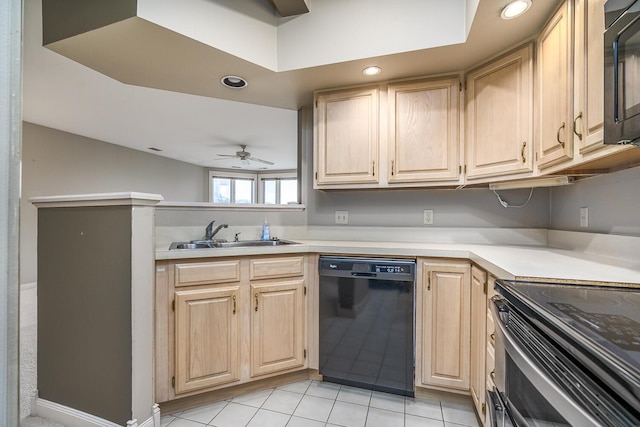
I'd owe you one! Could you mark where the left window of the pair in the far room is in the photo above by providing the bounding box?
[209,171,256,204]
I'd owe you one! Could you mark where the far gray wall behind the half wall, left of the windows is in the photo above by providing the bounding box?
[20,122,209,283]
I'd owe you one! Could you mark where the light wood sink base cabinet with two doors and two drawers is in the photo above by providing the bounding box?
[155,255,307,402]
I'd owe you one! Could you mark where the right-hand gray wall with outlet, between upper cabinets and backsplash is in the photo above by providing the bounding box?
[549,167,640,236]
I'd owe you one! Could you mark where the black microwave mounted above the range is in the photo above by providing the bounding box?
[604,0,640,146]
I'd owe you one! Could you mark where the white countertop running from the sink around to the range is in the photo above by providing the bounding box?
[156,240,640,286]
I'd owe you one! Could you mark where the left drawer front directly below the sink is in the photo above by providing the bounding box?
[175,260,240,287]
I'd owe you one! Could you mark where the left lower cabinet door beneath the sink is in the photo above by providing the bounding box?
[175,286,240,394]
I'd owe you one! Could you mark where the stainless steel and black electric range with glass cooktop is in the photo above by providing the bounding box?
[487,280,640,427]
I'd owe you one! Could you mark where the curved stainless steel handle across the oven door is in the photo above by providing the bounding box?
[492,301,599,426]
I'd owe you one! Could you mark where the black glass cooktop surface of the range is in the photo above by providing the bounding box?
[495,280,640,406]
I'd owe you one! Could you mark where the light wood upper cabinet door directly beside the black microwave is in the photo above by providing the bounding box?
[573,0,604,154]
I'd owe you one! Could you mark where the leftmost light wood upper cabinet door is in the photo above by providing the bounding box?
[315,87,379,186]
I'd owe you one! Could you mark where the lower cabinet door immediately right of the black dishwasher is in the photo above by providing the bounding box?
[421,263,470,390]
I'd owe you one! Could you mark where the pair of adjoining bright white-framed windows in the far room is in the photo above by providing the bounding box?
[209,170,299,205]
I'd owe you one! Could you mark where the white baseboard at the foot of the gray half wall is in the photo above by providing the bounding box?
[34,398,160,427]
